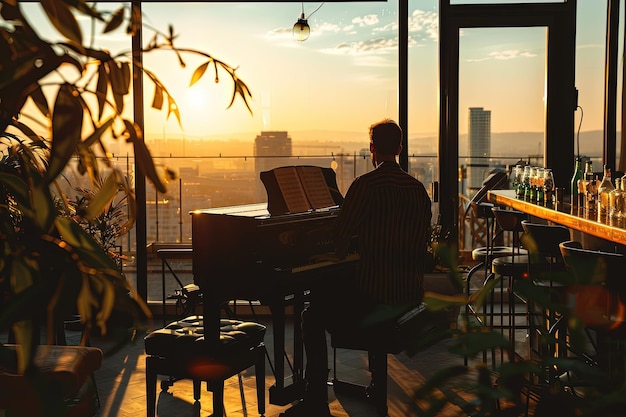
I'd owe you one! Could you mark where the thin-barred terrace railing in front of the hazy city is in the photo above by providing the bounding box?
[59,153,588,302]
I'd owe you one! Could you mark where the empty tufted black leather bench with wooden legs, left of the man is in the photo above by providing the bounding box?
[144,316,266,417]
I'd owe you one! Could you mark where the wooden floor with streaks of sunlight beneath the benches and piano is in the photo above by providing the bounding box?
[89,316,472,417]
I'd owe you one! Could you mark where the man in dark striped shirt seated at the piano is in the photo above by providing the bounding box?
[282,119,431,417]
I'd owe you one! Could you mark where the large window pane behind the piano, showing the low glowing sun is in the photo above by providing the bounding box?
[137,2,404,299]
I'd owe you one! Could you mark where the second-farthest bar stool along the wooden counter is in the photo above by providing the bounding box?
[489,207,528,368]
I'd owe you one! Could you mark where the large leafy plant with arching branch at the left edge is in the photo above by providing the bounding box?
[0,0,251,372]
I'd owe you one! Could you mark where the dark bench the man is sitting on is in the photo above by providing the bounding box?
[330,303,432,417]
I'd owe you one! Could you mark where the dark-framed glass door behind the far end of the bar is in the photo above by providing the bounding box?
[439,0,576,247]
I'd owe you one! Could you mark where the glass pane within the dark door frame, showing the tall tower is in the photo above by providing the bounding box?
[459,27,546,198]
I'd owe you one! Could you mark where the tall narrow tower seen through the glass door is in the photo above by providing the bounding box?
[465,107,491,193]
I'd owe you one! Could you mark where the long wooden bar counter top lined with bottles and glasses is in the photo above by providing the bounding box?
[487,190,626,245]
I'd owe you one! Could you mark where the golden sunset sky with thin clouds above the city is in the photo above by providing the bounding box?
[13,0,608,144]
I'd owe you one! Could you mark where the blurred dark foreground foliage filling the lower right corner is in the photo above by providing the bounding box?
[410,240,626,417]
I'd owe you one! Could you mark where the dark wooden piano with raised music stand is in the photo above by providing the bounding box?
[191,168,358,405]
